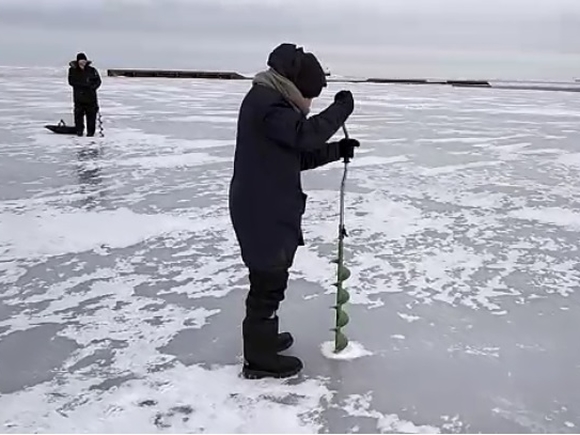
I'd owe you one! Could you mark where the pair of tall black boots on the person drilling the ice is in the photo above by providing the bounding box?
[242,317,303,379]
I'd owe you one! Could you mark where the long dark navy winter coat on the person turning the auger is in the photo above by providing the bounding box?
[229,85,352,270]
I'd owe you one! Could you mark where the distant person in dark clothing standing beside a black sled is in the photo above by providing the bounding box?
[68,53,101,136]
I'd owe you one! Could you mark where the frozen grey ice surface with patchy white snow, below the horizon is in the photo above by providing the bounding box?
[0,66,580,433]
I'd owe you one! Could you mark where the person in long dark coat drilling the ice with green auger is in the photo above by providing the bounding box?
[229,43,359,379]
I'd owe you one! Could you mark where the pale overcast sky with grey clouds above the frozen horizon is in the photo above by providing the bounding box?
[0,0,580,79]
